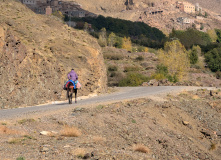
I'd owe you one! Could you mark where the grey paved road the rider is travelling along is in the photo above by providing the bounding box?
[0,86,212,121]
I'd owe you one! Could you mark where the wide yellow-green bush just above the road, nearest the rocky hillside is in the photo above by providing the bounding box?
[119,73,150,86]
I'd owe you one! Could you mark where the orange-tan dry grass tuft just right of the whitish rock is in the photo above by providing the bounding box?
[61,126,81,137]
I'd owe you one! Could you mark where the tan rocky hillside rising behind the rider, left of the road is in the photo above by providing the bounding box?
[0,0,106,108]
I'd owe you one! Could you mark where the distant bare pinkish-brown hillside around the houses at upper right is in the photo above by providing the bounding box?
[74,0,221,34]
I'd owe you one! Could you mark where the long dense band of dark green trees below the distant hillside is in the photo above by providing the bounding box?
[72,15,166,48]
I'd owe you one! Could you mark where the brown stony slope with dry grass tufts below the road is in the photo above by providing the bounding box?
[0,89,221,160]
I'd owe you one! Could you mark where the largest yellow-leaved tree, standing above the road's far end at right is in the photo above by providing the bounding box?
[159,40,190,80]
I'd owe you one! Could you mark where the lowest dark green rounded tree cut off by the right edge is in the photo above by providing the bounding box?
[205,47,221,72]
